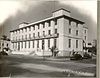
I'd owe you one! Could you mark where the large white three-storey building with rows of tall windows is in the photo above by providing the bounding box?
[10,9,88,56]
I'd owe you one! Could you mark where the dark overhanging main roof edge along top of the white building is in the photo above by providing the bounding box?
[10,15,85,32]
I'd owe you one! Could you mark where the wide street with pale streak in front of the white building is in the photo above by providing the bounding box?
[0,55,96,77]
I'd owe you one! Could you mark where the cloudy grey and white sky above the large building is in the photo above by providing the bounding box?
[0,0,97,41]
